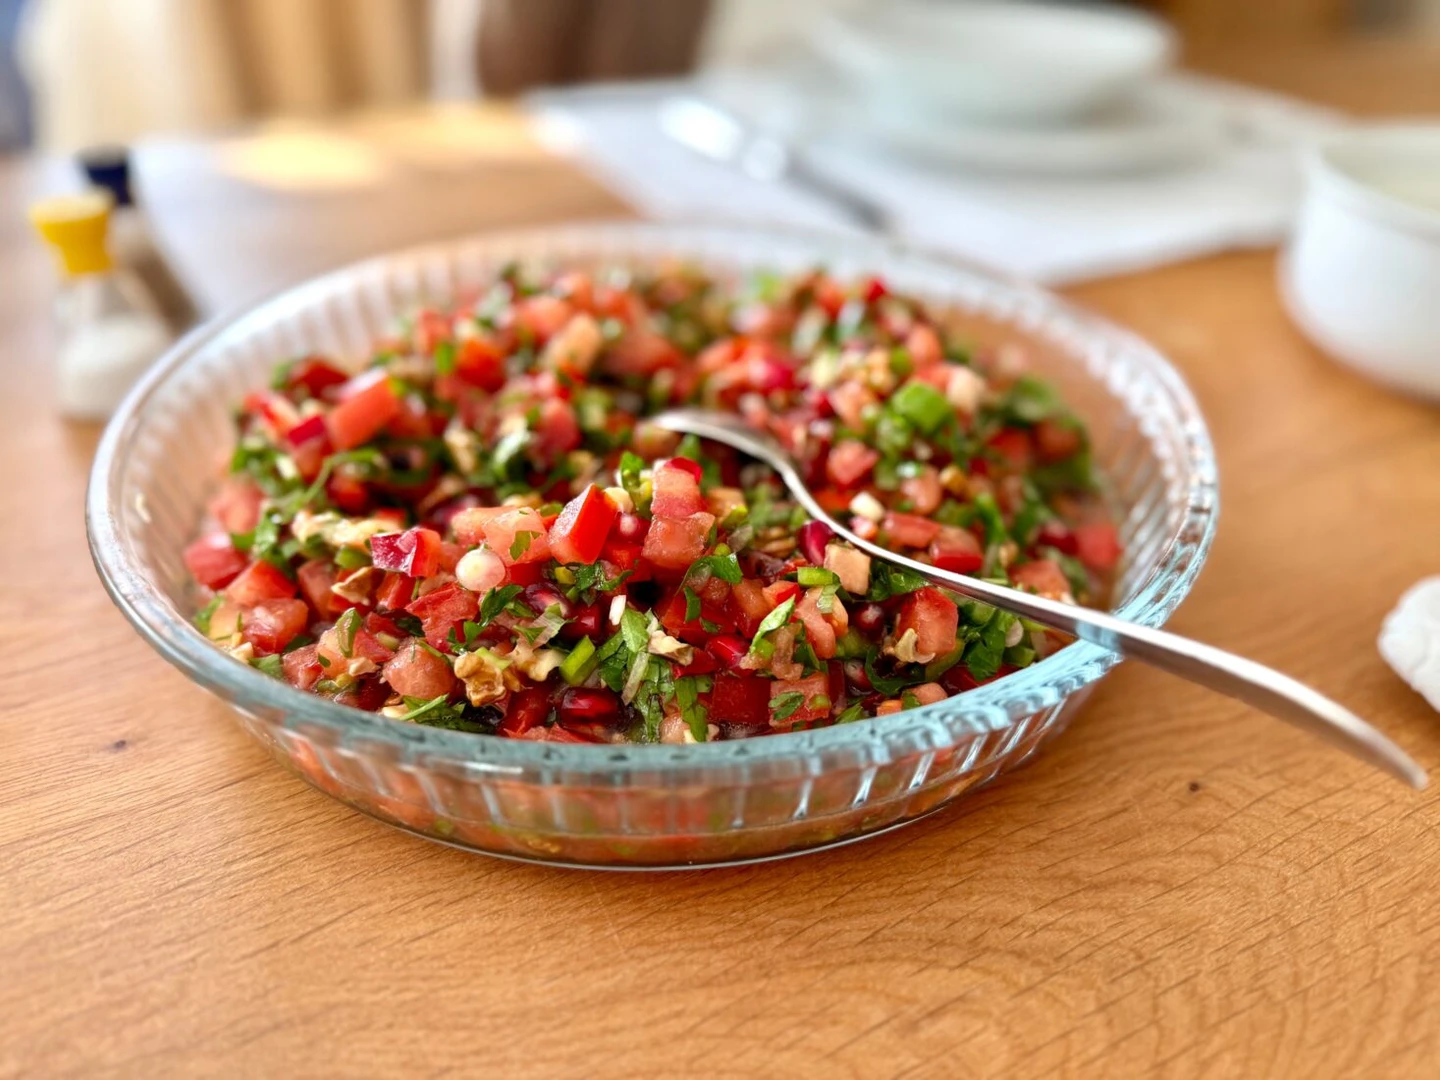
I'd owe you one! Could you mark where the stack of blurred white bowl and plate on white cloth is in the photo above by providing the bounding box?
[811,0,1228,174]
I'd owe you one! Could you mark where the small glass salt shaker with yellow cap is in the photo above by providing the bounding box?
[30,190,174,420]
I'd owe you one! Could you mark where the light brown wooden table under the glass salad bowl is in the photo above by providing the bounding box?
[8,38,1440,1077]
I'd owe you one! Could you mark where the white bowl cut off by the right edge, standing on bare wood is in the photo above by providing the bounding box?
[1280,124,1440,399]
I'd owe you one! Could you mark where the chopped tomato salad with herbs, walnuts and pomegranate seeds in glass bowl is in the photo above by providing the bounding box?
[184,266,1120,743]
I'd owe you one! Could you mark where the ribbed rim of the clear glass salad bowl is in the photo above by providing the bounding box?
[85,220,1218,782]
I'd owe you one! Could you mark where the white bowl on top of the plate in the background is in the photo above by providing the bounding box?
[814,0,1175,124]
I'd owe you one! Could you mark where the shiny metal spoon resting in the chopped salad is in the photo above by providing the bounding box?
[649,409,1427,789]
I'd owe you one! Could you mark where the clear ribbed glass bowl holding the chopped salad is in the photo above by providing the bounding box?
[86,222,1217,867]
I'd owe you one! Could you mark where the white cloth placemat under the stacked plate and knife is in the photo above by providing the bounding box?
[528,75,1339,284]
